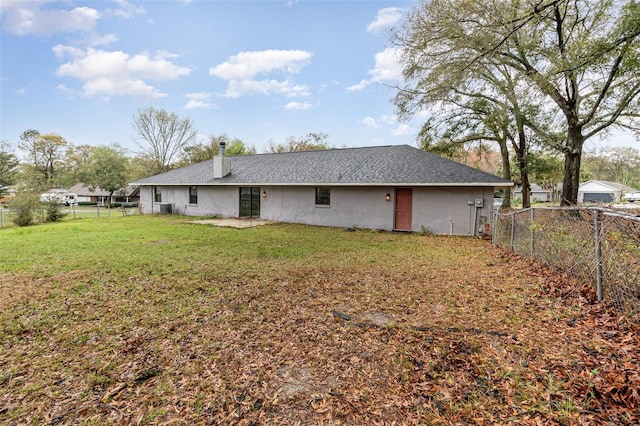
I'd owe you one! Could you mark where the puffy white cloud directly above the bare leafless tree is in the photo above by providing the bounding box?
[53,45,191,100]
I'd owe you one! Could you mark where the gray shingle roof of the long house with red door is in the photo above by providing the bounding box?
[132,145,511,186]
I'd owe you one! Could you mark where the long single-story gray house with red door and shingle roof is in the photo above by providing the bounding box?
[131,144,512,235]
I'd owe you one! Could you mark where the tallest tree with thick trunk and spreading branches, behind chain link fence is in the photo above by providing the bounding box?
[396,0,640,205]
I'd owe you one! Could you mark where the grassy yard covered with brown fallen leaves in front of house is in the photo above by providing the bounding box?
[0,216,640,425]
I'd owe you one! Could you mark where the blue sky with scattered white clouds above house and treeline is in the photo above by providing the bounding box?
[0,0,420,153]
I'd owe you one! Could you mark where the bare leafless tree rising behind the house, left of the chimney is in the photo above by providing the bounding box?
[133,107,197,173]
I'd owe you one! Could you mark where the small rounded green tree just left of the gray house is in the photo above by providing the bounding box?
[85,144,129,199]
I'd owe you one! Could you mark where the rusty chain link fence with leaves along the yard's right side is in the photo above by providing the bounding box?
[493,206,640,317]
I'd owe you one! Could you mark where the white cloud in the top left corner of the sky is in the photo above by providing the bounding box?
[1,0,100,36]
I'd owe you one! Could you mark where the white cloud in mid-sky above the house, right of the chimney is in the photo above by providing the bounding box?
[209,50,313,98]
